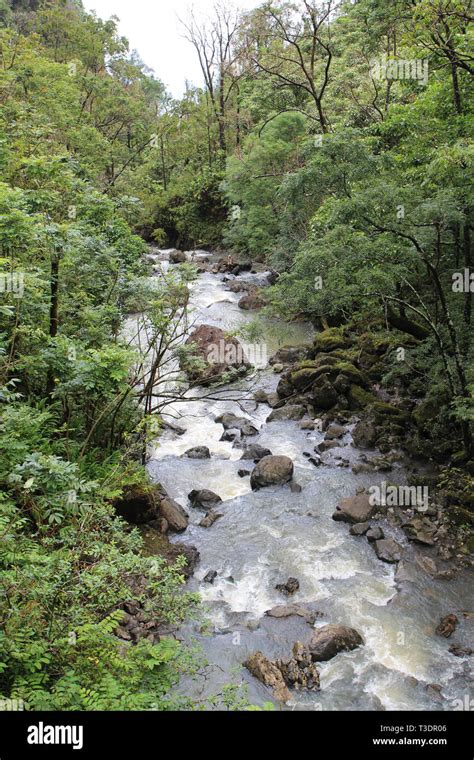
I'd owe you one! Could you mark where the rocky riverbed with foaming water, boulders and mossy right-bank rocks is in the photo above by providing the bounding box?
[131,246,474,710]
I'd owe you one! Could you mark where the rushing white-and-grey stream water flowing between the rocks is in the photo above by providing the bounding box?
[145,249,474,710]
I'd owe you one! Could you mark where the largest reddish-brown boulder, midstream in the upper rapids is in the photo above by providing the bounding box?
[180,325,250,385]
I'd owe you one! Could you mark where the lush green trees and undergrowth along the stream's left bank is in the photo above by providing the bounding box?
[0,2,202,710]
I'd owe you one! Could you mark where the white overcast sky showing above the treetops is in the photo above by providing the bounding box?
[83,0,262,97]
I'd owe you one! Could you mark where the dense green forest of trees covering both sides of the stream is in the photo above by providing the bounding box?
[0,0,474,709]
